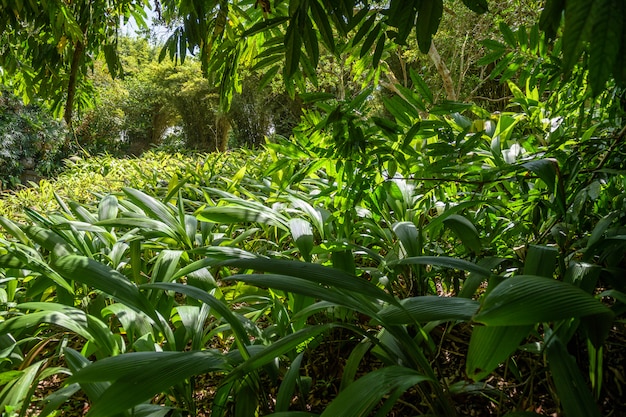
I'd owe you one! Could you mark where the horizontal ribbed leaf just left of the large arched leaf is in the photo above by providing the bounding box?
[379,296,480,324]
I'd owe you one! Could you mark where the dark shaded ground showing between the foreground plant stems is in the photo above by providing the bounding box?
[28,322,626,417]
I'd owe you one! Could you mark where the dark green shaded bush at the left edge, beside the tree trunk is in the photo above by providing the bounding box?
[0,88,67,187]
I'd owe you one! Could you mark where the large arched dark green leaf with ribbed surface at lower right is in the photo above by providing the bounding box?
[474,275,612,326]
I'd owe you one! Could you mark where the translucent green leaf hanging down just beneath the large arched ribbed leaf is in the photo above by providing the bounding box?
[465,326,533,381]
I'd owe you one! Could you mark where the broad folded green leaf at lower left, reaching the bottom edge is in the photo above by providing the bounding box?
[68,350,228,417]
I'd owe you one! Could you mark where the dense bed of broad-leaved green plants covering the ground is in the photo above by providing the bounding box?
[0,64,626,416]
